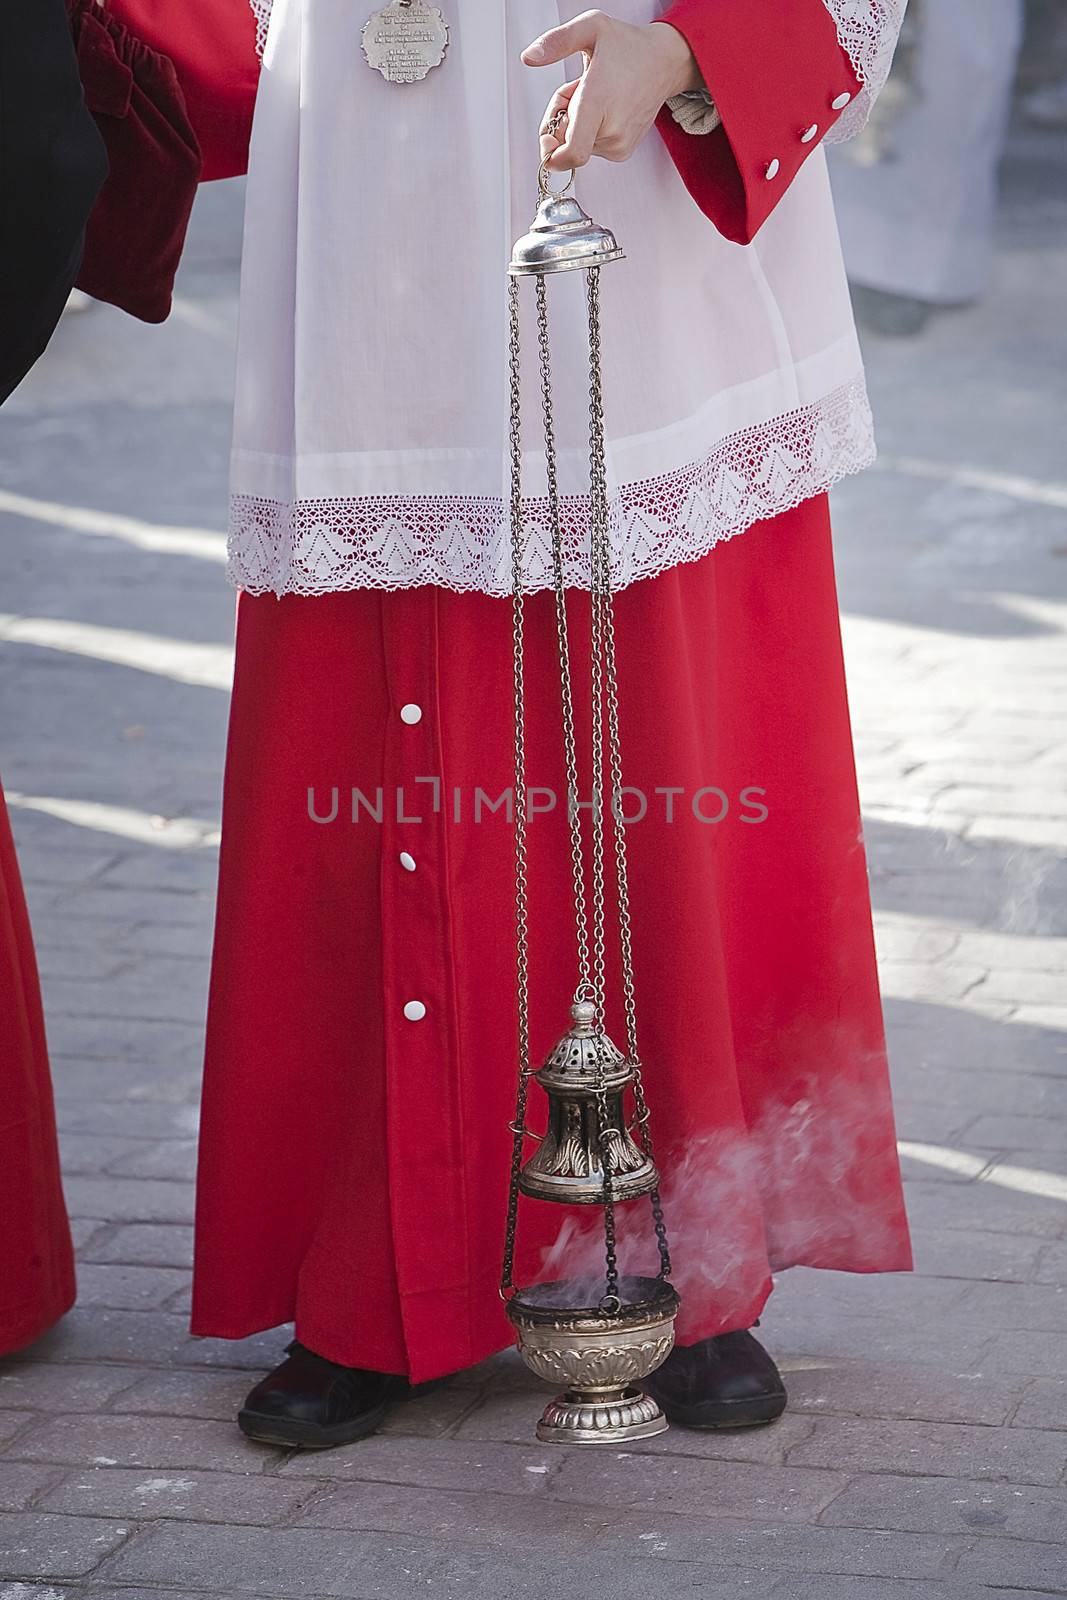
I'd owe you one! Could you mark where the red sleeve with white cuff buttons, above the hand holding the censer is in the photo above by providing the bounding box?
[657,0,861,245]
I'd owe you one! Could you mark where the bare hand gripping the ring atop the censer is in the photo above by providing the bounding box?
[523,11,702,171]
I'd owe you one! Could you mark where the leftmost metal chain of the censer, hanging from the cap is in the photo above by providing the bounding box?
[501,278,530,1299]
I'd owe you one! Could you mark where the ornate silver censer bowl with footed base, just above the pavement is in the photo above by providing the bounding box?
[507,1277,678,1445]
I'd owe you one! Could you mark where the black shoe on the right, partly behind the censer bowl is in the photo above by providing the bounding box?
[645,1328,785,1429]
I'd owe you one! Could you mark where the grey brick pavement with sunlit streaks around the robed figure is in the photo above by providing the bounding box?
[0,124,1067,1600]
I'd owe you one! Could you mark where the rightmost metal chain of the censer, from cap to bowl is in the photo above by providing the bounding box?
[587,267,670,1278]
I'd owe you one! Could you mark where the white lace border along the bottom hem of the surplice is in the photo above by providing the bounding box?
[229,379,875,595]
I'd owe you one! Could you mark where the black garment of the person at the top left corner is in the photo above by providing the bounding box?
[0,0,107,402]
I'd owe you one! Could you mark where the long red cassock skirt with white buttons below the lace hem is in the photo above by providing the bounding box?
[192,498,910,1381]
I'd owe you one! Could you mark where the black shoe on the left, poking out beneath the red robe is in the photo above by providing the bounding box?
[237,1341,430,1450]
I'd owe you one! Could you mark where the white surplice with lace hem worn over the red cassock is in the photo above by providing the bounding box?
[230,0,902,594]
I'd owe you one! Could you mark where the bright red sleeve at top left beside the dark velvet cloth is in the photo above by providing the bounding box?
[107,0,259,179]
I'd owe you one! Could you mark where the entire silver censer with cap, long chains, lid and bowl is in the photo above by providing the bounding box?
[501,163,678,1443]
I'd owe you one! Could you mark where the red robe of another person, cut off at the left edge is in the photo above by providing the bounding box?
[0,789,74,1355]
